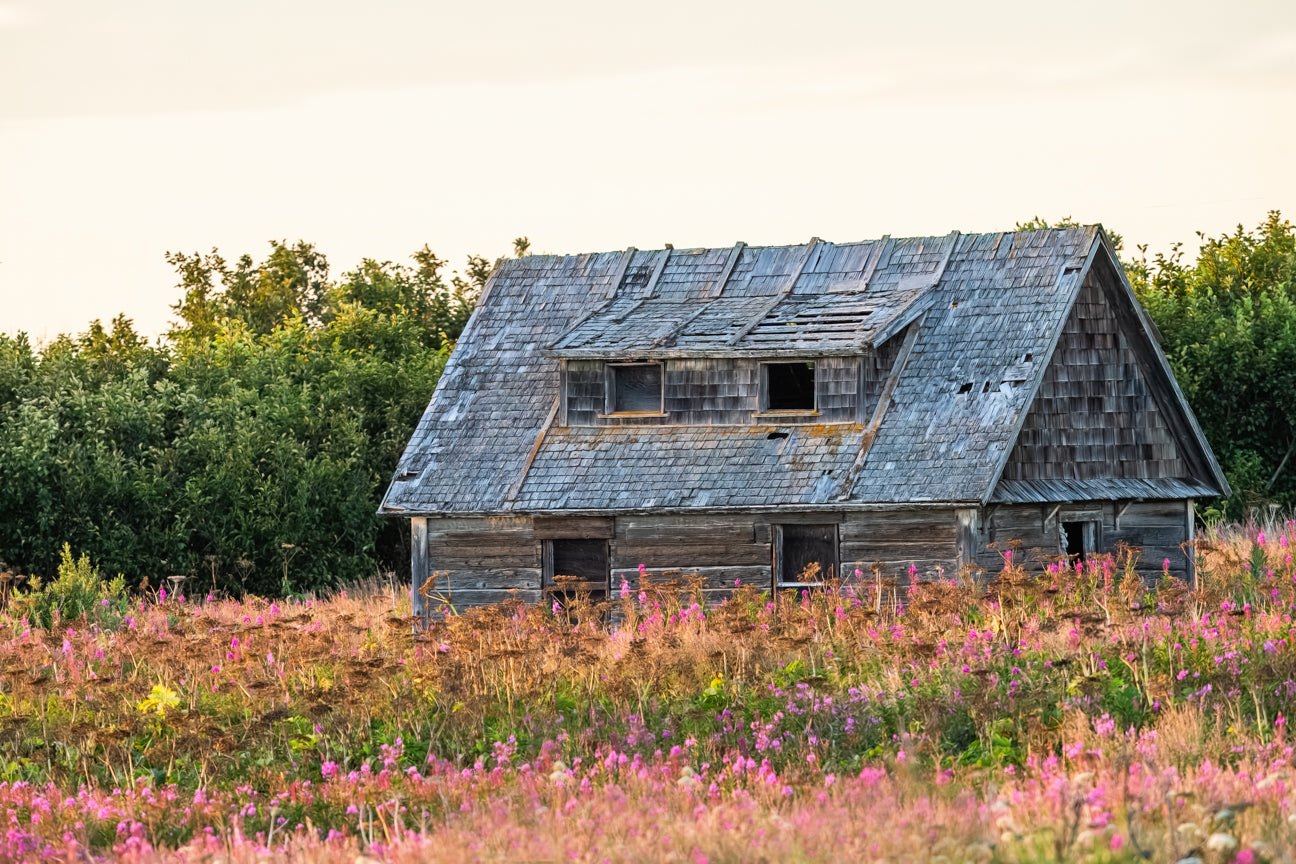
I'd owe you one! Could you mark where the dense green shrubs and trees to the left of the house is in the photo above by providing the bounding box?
[0,244,486,593]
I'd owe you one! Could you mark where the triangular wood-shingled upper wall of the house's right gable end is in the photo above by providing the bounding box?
[994,273,1186,481]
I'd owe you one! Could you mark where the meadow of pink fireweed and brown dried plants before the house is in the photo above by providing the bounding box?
[0,522,1296,864]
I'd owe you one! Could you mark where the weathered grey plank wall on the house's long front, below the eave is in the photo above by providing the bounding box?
[425,508,959,608]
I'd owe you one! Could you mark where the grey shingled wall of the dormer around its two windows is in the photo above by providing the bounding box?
[565,357,865,426]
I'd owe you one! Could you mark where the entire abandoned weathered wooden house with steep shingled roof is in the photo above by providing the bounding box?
[381,225,1227,610]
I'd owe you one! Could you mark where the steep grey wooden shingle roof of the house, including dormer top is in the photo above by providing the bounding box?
[381,227,1227,514]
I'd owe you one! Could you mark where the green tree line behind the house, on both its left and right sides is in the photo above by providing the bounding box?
[0,220,1296,595]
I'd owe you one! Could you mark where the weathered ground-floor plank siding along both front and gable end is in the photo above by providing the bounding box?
[411,500,1192,609]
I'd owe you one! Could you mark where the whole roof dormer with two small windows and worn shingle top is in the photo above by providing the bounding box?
[544,234,956,426]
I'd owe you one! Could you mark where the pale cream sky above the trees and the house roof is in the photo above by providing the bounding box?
[0,0,1296,338]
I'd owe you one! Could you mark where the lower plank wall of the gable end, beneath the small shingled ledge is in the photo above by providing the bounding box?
[976,500,1192,579]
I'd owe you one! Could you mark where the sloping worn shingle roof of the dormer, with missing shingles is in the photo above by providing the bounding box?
[546,233,959,359]
